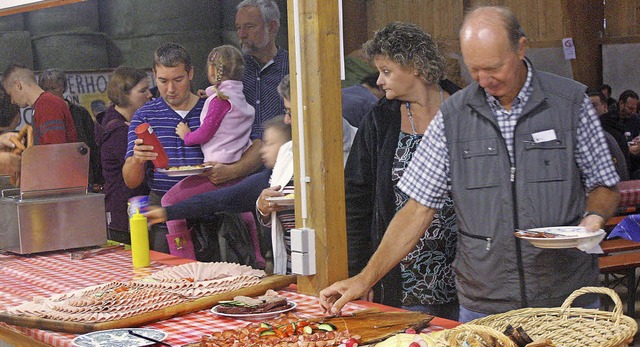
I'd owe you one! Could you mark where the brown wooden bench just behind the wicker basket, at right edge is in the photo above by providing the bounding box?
[598,251,640,318]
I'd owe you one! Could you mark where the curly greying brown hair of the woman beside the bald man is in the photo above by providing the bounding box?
[362,22,445,84]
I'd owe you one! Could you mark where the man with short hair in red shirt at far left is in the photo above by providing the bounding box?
[2,64,78,145]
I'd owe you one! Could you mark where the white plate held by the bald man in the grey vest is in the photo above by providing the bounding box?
[515,226,604,248]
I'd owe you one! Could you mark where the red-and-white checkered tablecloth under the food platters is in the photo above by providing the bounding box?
[0,250,366,347]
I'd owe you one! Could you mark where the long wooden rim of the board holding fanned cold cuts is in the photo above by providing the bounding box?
[0,275,296,334]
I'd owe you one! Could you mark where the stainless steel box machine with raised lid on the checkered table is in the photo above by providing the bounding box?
[0,143,107,254]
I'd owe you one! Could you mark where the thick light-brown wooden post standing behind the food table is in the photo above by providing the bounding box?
[287,0,348,295]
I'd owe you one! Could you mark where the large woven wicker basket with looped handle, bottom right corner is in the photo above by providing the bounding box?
[458,287,638,347]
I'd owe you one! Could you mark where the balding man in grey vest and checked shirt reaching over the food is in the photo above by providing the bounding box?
[320,7,619,322]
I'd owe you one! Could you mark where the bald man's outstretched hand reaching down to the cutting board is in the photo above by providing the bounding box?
[319,275,370,315]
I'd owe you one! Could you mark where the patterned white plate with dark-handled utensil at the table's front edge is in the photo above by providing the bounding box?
[72,328,168,347]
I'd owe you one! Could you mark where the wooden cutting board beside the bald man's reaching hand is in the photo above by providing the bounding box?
[182,309,433,347]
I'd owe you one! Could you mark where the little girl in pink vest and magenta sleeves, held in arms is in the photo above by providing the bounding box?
[162,45,264,266]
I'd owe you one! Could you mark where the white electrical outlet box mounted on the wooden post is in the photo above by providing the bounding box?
[291,228,316,276]
